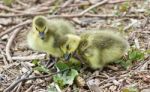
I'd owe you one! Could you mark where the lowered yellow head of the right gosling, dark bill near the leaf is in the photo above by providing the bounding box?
[60,34,80,61]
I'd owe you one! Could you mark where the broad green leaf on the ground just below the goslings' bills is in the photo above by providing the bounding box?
[53,59,78,88]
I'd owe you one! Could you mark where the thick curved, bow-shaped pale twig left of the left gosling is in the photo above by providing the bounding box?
[6,28,21,62]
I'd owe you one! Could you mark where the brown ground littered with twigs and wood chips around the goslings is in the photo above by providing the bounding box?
[0,0,150,92]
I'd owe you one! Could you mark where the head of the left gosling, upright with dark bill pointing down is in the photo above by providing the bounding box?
[32,16,48,40]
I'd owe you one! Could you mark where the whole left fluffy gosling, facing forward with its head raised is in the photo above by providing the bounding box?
[27,16,75,57]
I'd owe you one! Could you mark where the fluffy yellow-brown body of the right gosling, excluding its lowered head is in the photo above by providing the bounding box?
[77,30,129,69]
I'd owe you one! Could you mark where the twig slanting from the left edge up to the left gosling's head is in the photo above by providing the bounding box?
[0,20,31,38]
